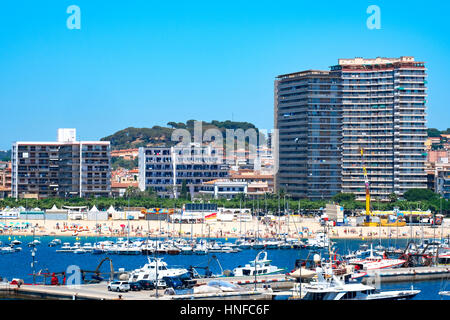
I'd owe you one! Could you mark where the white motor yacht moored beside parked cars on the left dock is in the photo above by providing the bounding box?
[129,257,189,282]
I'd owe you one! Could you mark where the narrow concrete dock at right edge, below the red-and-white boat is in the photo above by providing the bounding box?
[362,266,450,283]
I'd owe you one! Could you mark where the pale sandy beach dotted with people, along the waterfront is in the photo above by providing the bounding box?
[0,217,450,240]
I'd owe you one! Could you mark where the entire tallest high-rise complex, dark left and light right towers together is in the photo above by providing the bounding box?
[275,57,427,200]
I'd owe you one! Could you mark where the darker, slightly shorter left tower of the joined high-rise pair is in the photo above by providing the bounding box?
[273,70,341,199]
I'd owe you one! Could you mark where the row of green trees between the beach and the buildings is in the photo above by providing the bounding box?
[0,187,450,215]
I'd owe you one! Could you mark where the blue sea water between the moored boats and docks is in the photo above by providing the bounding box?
[0,235,450,300]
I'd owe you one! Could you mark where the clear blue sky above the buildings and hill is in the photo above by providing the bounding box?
[0,0,450,149]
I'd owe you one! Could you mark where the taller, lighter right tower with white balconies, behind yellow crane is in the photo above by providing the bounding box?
[331,57,427,199]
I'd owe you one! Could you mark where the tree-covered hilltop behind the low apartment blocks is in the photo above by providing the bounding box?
[100,120,258,149]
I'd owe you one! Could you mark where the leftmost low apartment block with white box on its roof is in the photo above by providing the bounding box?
[12,129,111,198]
